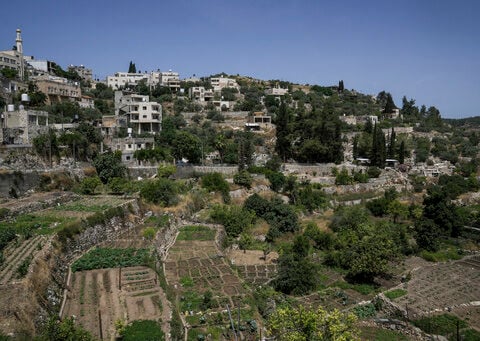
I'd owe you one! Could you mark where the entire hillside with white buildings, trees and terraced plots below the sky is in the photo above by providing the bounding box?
[0,30,480,340]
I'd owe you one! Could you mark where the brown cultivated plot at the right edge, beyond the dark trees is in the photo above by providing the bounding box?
[394,255,480,329]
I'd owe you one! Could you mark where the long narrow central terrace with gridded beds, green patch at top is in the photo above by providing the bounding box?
[165,226,258,340]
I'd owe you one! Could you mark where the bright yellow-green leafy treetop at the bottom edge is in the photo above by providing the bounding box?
[267,306,358,341]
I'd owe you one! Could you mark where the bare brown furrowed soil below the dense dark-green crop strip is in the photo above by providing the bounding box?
[63,266,163,339]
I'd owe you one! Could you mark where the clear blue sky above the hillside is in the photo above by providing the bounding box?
[0,0,480,117]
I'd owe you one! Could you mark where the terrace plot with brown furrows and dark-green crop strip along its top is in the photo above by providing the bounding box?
[62,248,168,339]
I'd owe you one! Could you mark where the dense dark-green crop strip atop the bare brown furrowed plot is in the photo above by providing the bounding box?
[72,248,149,272]
